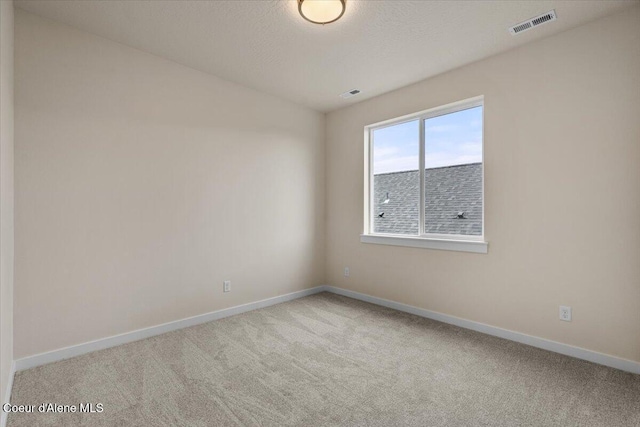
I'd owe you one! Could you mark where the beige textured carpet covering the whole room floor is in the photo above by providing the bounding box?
[8,293,640,427]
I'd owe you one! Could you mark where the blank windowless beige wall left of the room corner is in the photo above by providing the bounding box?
[15,10,325,358]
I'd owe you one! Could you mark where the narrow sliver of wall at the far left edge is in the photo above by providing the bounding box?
[0,1,13,403]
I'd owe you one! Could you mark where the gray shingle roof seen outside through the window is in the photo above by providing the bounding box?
[373,163,482,236]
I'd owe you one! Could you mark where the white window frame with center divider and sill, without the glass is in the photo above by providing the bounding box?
[360,96,489,253]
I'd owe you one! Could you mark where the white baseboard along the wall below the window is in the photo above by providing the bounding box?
[324,286,640,374]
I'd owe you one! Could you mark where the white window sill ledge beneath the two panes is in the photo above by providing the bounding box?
[360,234,489,254]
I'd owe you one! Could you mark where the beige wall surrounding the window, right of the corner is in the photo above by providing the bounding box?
[326,6,640,361]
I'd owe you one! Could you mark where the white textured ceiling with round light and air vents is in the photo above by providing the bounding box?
[16,0,638,111]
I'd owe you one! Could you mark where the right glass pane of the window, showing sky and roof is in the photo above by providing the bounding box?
[424,106,482,236]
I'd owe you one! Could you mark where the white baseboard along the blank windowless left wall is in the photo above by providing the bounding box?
[15,286,326,371]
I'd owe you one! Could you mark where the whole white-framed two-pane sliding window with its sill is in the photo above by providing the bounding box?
[361,97,487,253]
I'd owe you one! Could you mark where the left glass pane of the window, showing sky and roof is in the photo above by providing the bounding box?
[372,120,420,235]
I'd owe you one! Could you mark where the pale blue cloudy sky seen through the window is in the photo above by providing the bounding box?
[373,107,482,174]
